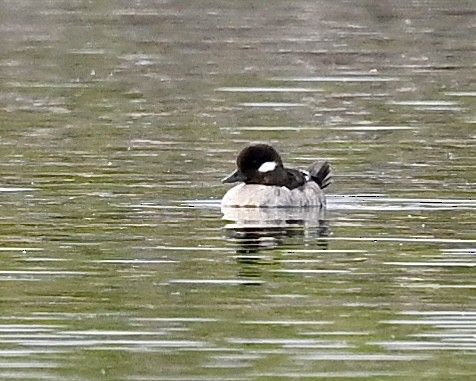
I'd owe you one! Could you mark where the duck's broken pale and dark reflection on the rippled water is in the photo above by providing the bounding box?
[222,207,329,254]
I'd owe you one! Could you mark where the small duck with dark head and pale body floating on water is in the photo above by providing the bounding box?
[221,144,331,207]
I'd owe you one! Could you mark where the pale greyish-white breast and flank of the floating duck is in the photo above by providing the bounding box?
[221,182,325,207]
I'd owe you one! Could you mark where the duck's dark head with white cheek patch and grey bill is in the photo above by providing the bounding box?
[222,144,283,184]
